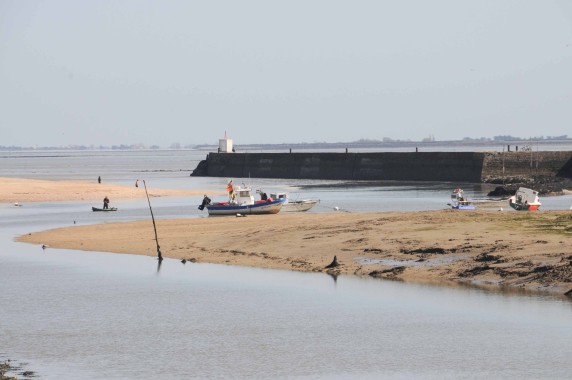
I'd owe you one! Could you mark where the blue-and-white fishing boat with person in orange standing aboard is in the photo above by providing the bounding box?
[204,181,286,216]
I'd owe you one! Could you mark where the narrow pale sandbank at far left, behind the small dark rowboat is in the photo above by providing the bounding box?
[0,177,212,204]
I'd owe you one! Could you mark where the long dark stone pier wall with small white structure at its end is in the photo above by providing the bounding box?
[192,152,572,182]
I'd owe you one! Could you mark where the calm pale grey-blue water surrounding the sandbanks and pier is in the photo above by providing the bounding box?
[0,151,572,379]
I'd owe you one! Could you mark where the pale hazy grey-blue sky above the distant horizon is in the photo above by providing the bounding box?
[0,0,572,147]
